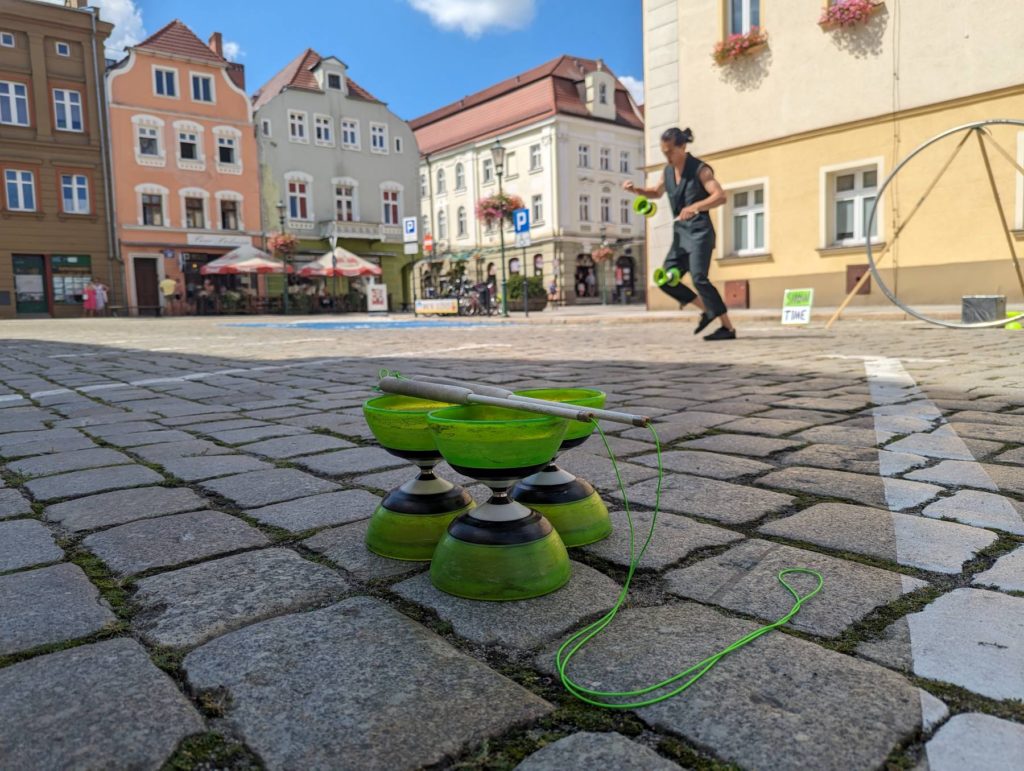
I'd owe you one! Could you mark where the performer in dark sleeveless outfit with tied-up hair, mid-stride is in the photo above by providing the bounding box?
[623,128,736,340]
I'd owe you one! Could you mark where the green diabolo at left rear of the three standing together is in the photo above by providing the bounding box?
[362,394,474,561]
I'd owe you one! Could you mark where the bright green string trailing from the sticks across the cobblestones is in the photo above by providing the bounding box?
[555,420,824,710]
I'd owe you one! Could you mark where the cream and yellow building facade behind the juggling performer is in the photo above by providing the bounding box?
[644,0,1024,309]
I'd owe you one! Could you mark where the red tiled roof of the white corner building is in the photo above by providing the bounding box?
[410,56,643,155]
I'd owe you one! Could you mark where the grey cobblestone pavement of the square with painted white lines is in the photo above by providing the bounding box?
[0,319,1024,771]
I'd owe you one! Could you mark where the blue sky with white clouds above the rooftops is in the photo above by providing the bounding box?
[77,0,643,120]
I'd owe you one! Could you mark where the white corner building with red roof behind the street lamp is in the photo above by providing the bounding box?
[412,56,645,304]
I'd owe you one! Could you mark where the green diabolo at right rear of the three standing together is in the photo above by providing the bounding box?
[510,388,611,547]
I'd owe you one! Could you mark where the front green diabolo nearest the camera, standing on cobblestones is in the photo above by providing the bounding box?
[427,404,571,600]
